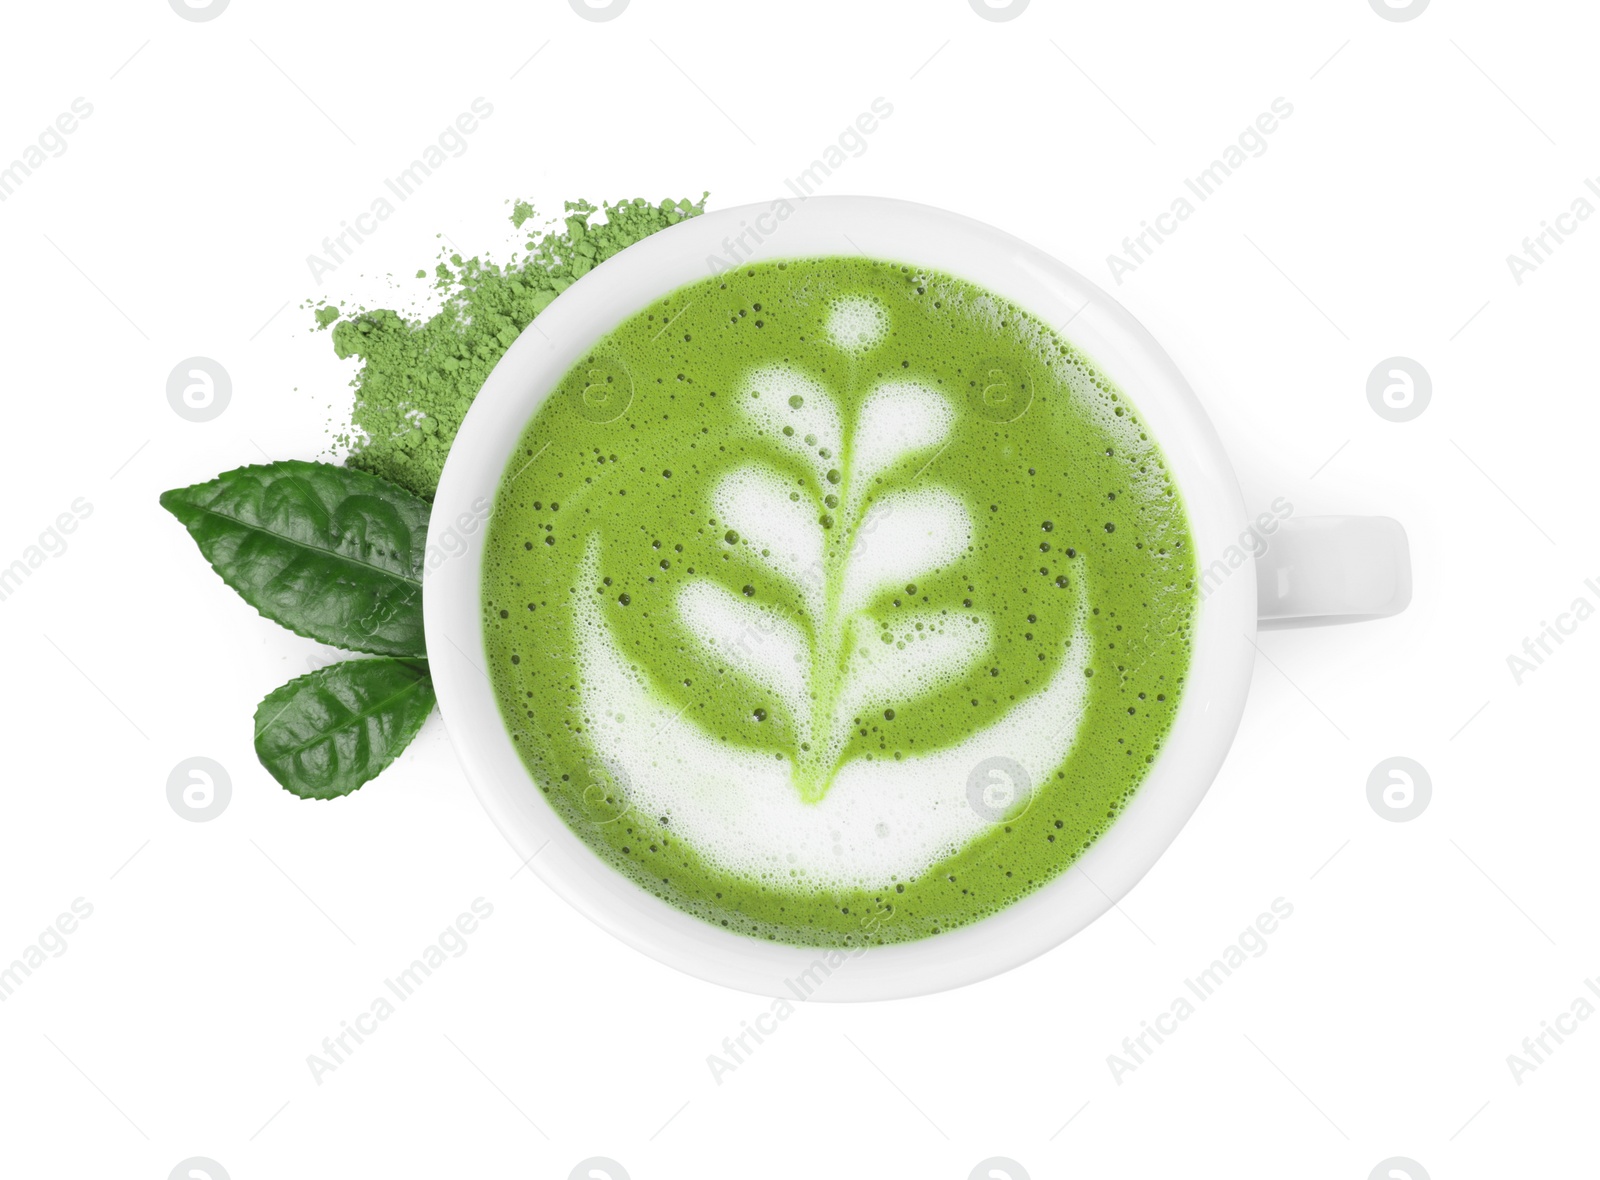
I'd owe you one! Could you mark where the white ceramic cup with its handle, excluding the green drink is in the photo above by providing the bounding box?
[422,197,1411,999]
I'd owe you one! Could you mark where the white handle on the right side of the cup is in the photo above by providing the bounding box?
[1256,516,1411,630]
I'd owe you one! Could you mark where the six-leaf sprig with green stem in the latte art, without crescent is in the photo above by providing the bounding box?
[678,358,989,803]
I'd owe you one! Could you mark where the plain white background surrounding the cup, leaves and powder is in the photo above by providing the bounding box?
[0,0,1600,1180]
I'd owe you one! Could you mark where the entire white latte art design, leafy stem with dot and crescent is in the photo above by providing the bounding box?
[579,308,1088,887]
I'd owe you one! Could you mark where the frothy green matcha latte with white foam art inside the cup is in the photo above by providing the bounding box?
[483,257,1197,945]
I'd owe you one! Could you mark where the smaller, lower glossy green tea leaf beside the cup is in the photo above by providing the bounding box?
[256,659,434,799]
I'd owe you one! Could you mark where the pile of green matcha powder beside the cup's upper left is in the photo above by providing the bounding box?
[315,197,706,499]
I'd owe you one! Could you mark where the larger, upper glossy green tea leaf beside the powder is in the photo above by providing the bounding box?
[162,459,429,656]
